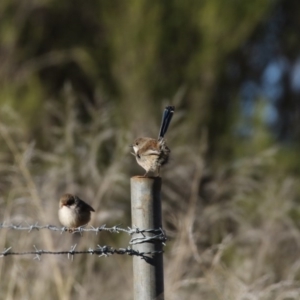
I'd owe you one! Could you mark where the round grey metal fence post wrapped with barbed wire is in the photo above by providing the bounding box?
[130,176,164,300]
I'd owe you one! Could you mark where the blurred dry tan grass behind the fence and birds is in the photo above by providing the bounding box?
[0,97,300,300]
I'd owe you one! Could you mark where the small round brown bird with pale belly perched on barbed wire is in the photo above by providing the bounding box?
[58,194,95,229]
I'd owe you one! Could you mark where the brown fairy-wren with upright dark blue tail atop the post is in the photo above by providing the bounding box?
[132,106,175,177]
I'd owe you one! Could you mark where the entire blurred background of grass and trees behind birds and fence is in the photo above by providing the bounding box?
[0,0,300,300]
